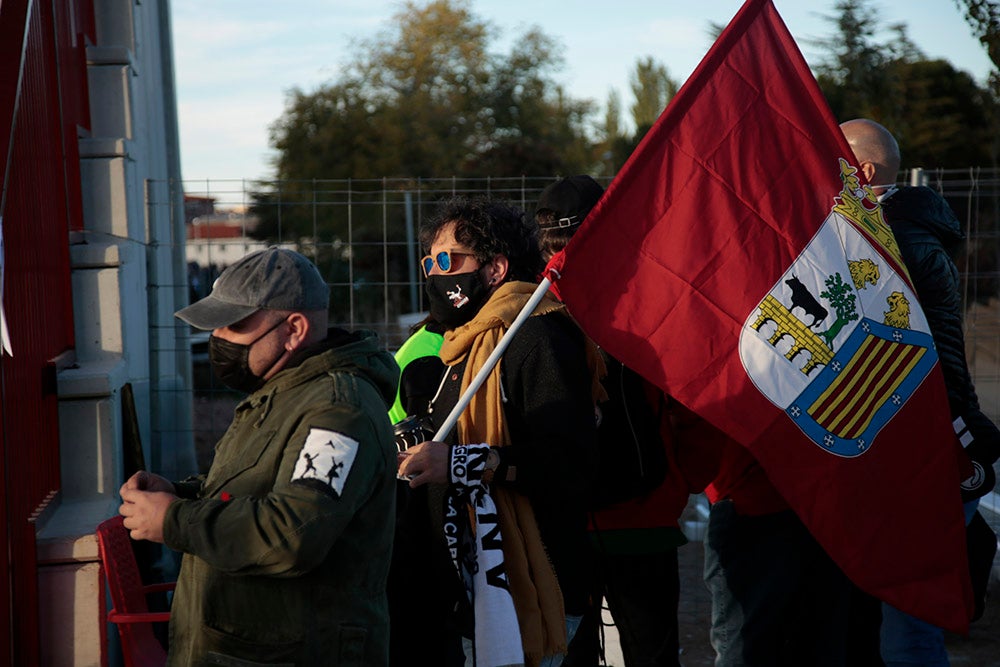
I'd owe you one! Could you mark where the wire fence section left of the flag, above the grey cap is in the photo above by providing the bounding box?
[176,177,604,349]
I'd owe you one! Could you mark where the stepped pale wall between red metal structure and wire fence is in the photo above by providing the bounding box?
[38,0,196,665]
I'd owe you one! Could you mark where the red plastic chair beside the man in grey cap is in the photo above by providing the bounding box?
[97,516,176,667]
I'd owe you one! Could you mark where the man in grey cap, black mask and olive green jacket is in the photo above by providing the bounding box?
[119,248,399,665]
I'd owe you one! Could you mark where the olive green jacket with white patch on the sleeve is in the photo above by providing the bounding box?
[164,330,399,667]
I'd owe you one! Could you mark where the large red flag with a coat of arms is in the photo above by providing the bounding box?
[550,0,971,633]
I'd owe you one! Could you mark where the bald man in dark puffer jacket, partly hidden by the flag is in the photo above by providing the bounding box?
[840,118,1000,667]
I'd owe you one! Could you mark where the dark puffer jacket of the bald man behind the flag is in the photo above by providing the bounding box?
[882,187,1000,470]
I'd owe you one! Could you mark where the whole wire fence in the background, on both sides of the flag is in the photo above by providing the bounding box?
[160,168,1000,527]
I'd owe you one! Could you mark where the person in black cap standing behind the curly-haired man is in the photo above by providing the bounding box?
[535,175,688,667]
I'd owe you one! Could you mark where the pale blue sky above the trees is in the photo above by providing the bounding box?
[171,0,990,180]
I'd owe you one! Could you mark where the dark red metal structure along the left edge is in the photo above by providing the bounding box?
[0,0,94,665]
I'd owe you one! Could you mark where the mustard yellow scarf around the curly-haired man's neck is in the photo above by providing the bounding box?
[439,282,607,665]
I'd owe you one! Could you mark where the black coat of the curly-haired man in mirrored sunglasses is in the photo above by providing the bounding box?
[389,313,597,667]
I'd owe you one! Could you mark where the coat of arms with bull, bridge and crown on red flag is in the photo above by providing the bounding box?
[740,159,937,457]
